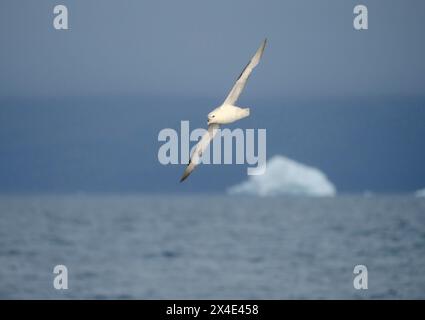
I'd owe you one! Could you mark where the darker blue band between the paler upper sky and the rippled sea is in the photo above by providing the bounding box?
[0,97,425,194]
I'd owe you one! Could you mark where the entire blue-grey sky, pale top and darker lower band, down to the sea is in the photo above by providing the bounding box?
[0,0,425,192]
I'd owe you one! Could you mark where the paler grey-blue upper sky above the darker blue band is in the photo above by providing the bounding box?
[0,0,425,98]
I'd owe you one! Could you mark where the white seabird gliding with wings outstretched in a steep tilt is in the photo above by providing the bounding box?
[180,39,267,182]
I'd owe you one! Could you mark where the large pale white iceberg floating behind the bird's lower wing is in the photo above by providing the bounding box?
[227,155,336,197]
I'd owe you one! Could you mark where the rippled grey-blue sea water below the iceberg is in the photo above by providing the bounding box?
[0,195,425,299]
